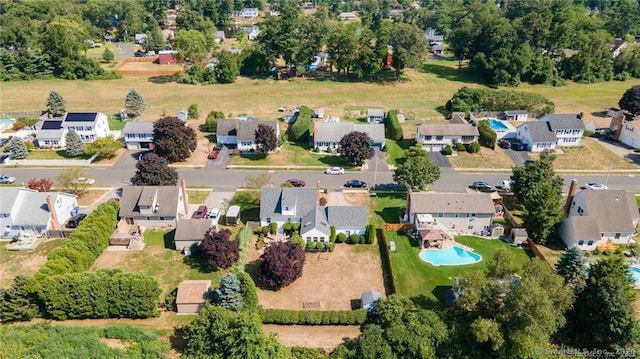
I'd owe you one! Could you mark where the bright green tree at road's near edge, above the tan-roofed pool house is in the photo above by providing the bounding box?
[393,147,440,191]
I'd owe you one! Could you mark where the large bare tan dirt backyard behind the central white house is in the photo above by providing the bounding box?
[249,244,385,310]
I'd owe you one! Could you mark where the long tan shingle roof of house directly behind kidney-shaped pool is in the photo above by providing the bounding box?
[409,192,495,214]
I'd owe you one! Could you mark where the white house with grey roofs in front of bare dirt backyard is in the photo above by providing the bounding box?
[260,187,368,242]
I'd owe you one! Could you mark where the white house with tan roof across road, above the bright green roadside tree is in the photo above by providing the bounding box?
[416,123,480,152]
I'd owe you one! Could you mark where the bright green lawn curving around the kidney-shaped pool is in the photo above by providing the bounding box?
[385,232,529,302]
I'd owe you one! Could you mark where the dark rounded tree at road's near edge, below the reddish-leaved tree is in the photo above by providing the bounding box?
[131,153,178,186]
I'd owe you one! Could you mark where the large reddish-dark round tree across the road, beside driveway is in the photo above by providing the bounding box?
[153,117,198,162]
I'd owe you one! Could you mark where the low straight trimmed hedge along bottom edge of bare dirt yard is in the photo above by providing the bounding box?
[259,308,367,325]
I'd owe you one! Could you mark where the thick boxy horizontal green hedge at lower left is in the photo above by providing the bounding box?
[36,269,160,320]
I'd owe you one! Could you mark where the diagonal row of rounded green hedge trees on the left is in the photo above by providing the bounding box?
[34,201,119,279]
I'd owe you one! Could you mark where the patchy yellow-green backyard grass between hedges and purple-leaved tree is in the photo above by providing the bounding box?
[91,230,225,298]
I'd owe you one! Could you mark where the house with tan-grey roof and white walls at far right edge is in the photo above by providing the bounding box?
[558,190,640,251]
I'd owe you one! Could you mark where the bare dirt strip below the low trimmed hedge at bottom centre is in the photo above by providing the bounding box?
[262,324,360,351]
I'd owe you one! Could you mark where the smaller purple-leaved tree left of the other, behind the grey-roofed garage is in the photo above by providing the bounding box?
[200,228,240,269]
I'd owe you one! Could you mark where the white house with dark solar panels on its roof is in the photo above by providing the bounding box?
[36,112,109,148]
